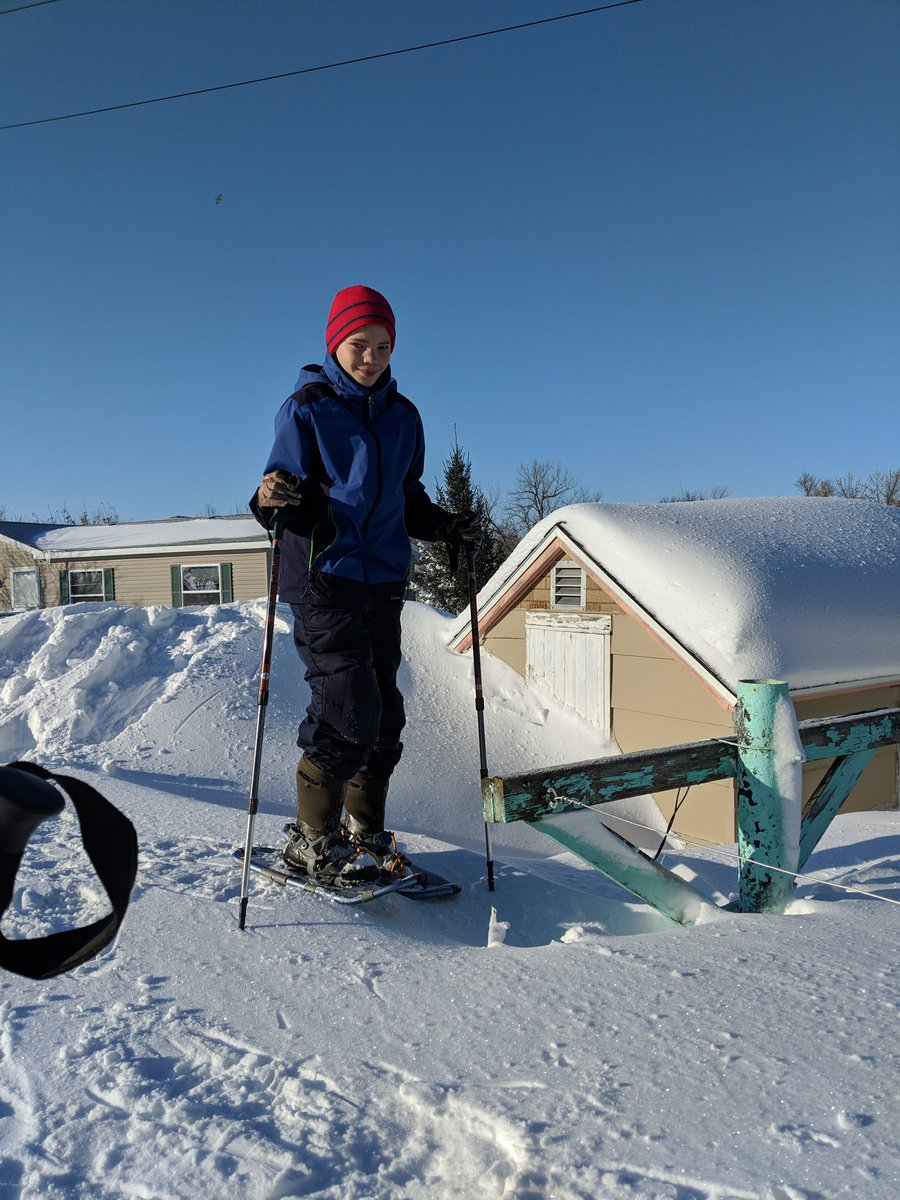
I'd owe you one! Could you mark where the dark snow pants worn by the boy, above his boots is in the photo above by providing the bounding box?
[290,572,406,779]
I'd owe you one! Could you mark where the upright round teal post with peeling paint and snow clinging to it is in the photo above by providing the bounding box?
[734,679,800,912]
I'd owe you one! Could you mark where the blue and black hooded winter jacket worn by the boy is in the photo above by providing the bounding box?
[251,355,448,602]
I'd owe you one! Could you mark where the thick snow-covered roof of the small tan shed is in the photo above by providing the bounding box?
[451,497,900,695]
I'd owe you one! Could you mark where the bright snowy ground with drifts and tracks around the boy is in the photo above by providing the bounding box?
[0,602,900,1200]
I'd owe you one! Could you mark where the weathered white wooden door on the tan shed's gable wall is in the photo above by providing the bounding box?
[526,612,612,734]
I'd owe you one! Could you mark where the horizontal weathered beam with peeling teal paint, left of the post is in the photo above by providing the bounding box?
[482,738,737,823]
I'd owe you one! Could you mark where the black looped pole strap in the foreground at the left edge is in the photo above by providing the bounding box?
[0,762,138,979]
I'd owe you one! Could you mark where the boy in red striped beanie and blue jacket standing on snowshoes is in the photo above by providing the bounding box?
[251,284,480,887]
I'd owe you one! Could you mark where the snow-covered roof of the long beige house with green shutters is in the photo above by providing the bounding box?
[0,516,269,558]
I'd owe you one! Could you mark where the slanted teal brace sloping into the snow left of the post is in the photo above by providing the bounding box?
[534,820,716,925]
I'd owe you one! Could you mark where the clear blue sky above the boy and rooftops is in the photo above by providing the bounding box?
[0,0,900,520]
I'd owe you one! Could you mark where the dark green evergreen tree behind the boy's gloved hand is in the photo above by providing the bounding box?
[415,436,503,613]
